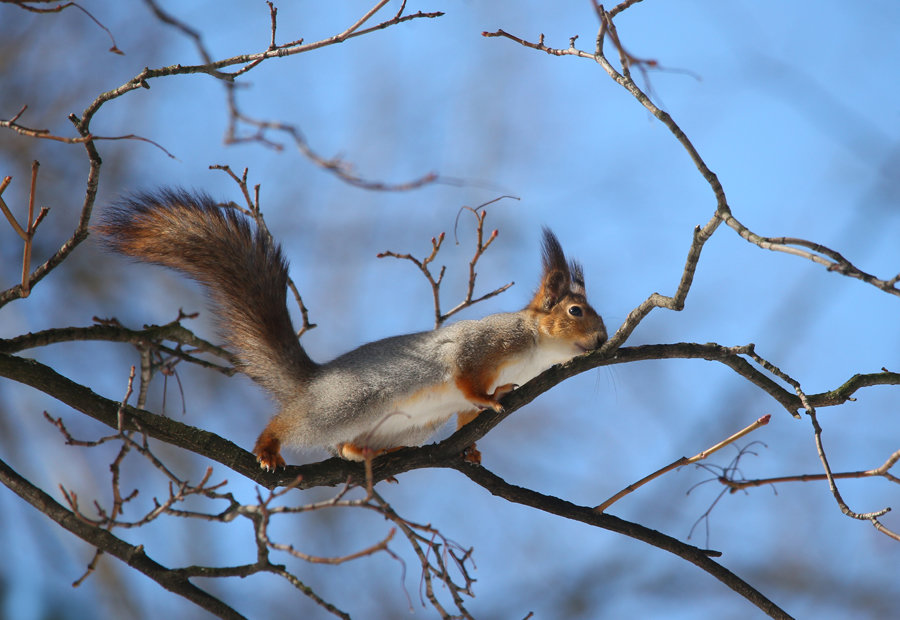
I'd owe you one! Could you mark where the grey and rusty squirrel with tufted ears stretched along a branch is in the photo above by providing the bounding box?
[95,189,606,471]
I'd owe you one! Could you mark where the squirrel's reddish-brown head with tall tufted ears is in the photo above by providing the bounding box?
[526,228,606,354]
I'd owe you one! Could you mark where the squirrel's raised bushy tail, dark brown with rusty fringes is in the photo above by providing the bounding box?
[95,190,317,403]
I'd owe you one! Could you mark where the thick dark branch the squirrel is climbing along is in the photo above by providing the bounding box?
[0,343,900,489]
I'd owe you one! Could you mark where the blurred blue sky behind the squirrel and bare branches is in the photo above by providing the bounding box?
[0,0,900,618]
